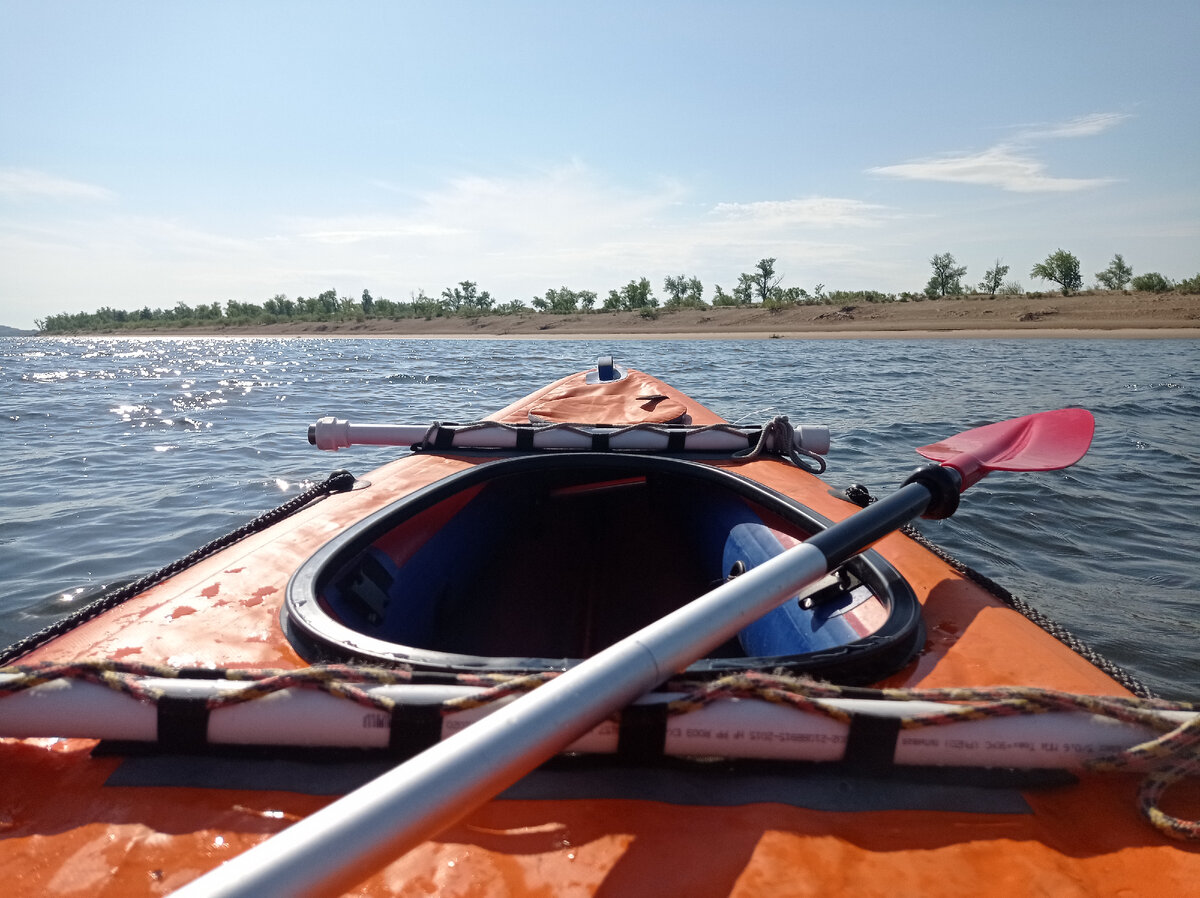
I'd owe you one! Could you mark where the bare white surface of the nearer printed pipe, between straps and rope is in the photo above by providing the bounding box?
[0,677,1196,768]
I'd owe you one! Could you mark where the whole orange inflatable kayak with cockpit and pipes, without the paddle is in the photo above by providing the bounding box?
[0,360,1200,898]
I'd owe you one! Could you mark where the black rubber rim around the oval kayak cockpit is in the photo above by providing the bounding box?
[281,453,925,684]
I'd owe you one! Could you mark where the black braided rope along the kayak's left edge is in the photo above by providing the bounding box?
[0,471,354,664]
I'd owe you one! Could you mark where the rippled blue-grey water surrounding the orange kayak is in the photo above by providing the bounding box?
[0,337,1200,698]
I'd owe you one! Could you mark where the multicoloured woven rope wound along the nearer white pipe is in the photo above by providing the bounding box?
[0,661,1200,840]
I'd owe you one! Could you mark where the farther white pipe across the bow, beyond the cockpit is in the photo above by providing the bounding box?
[310,417,829,455]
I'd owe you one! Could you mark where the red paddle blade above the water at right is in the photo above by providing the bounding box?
[917,408,1096,490]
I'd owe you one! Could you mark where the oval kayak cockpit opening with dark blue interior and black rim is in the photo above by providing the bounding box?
[284,453,924,682]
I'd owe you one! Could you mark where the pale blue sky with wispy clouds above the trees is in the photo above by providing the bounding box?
[0,0,1200,328]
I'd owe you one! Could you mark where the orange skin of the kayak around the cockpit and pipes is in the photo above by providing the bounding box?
[0,372,1200,898]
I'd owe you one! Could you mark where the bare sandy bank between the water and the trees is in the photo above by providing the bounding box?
[49,293,1200,340]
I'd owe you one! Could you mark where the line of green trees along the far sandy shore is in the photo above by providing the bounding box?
[35,250,1200,334]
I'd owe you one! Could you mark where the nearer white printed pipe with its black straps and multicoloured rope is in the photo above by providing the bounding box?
[0,660,1200,840]
